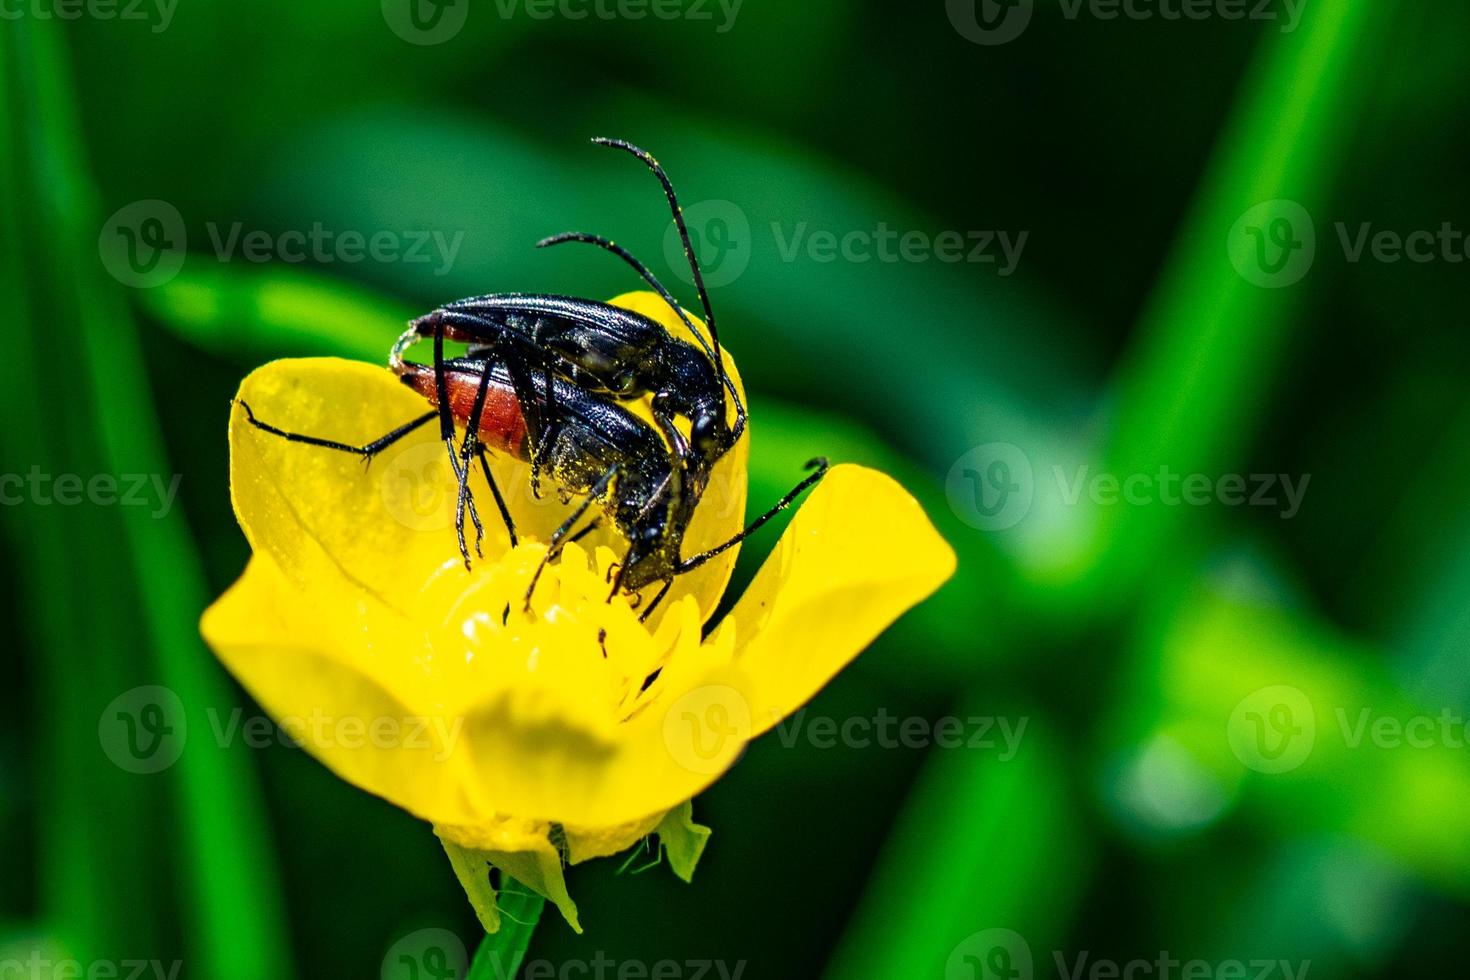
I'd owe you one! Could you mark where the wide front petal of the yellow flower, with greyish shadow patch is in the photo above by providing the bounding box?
[201,550,750,839]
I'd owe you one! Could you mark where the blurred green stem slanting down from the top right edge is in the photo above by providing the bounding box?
[1075,0,1394,607]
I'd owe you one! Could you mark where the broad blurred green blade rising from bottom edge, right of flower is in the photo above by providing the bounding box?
[826,714,1091,980]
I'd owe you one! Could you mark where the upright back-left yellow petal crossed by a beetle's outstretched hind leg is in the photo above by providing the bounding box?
[229,357,560,608]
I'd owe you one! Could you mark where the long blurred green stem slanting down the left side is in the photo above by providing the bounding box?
[6,18,291,980]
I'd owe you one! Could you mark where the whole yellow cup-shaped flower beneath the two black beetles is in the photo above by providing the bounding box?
[201,292,954,932]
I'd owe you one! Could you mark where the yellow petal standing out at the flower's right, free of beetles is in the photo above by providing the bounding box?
[719,466,956,735]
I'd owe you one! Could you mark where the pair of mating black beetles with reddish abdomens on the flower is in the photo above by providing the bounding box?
[243,140,828,617]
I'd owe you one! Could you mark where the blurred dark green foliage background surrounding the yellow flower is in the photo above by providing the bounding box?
[0,0,1470,980]
